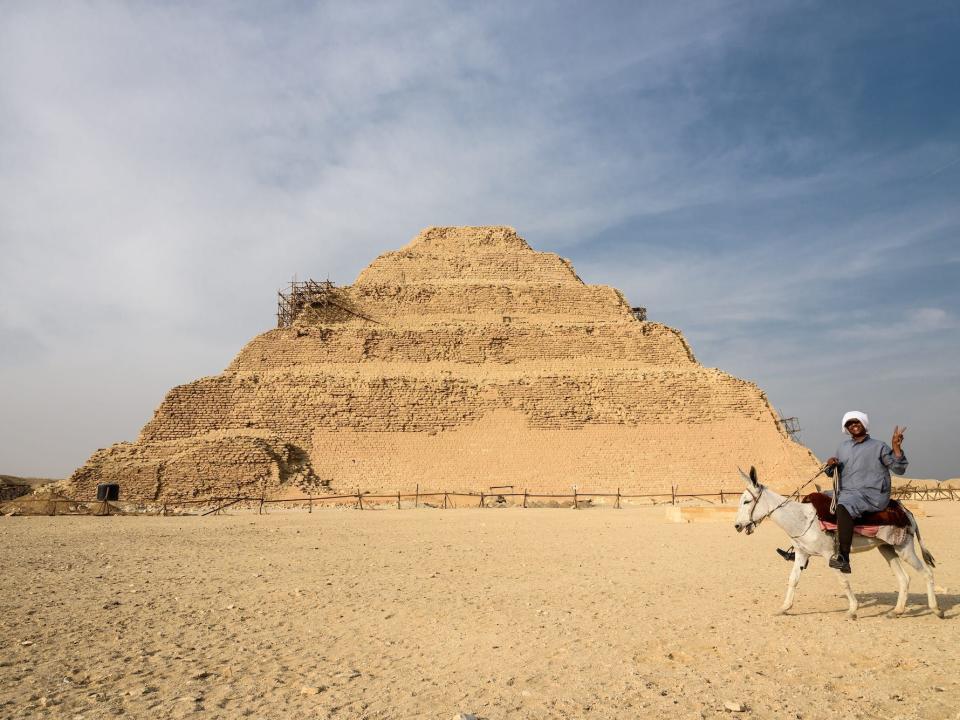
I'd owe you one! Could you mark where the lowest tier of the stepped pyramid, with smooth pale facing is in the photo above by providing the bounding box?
[71,410,816,507]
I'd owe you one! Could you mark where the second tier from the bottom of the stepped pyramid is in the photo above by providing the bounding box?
[140,363,773,445]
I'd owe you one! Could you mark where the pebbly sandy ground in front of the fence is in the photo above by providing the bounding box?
[0,502,960,719]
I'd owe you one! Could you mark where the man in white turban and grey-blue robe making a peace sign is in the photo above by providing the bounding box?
[777,410,907,573]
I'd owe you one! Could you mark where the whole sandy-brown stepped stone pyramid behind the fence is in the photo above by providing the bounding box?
[70,227,816,501]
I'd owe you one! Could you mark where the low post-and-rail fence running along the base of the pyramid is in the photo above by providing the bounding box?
[7,485,960,516]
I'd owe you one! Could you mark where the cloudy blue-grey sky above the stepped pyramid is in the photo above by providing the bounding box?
[0,2,960,478]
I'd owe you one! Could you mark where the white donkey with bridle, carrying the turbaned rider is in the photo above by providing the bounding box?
[734,467,943,619]
